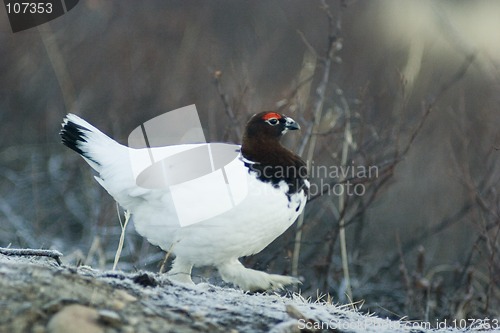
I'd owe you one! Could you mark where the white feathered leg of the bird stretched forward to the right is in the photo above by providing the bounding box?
[217,259,301,291]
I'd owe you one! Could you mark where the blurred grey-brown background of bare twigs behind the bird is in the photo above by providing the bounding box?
[0,0,500,322]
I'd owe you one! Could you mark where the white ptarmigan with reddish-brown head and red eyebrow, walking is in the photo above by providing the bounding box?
[60,112,309,291]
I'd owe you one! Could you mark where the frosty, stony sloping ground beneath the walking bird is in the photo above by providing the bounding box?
[0,254,500,333]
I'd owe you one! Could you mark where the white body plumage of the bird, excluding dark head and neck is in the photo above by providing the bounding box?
[61,114,306,290]
